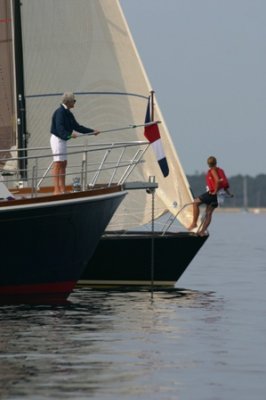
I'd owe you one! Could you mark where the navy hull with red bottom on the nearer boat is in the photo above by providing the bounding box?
[0,191,126,304]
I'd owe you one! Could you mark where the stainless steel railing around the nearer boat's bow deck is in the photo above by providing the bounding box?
[0,141,149,195]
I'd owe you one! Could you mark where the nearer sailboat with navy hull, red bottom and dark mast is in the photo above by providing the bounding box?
[0,0,127,304]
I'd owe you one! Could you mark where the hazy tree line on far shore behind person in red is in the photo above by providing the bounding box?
[187,173,266,208]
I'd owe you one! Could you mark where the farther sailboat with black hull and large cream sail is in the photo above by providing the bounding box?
[0,0,206,294]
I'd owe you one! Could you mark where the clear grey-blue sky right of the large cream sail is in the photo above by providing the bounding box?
[120,0,266,177]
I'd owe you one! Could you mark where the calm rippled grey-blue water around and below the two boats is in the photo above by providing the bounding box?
[0,212,266,400]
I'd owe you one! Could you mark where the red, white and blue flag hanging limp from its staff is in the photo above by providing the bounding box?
[144,98,169,177]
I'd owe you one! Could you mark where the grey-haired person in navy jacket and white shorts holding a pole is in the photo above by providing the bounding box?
[50,92,100,194]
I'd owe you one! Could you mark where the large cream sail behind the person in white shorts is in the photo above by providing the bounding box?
[18,0,192,229]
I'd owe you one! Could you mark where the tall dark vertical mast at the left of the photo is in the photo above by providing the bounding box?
[11,0,27,180]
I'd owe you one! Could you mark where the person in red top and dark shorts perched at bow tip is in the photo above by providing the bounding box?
[188,156,233,236]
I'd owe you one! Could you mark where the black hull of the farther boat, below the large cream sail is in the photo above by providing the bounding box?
[78,232,208,287]
